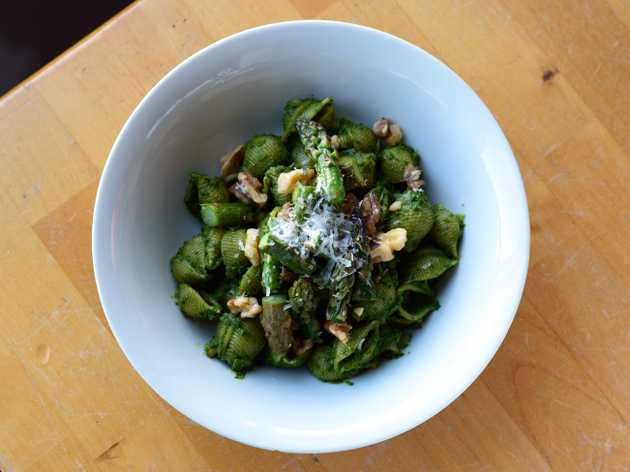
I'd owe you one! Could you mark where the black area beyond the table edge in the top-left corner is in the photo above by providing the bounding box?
[0,0,132,95]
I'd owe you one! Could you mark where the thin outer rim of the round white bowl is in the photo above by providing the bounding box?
[91,20,531,453]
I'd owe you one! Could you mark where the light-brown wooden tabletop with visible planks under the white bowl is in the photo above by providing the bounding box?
[0,0,630,472]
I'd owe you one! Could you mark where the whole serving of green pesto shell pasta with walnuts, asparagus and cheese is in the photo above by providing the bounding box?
[170,97,464,383]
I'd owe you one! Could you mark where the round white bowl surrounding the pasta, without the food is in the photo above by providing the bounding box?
[92,21,529,452]
